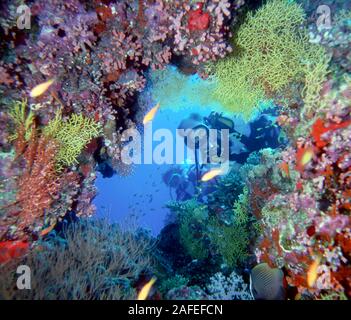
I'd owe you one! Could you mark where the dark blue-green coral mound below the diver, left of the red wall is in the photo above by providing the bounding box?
[168,162,253,268]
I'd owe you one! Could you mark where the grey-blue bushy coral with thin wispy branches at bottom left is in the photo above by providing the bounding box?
[0,220,152,300]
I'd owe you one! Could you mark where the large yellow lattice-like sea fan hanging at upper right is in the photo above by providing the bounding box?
[211,0,328,118]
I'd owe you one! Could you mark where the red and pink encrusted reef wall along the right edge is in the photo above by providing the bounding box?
[256,73,351,298]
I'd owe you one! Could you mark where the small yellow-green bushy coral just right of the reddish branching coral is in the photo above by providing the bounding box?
[44,112,101,170]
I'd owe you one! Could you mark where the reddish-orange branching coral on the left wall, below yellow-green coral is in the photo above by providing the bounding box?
[0,131,77,238]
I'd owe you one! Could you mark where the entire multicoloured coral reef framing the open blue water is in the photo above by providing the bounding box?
[0,0,351,300]
